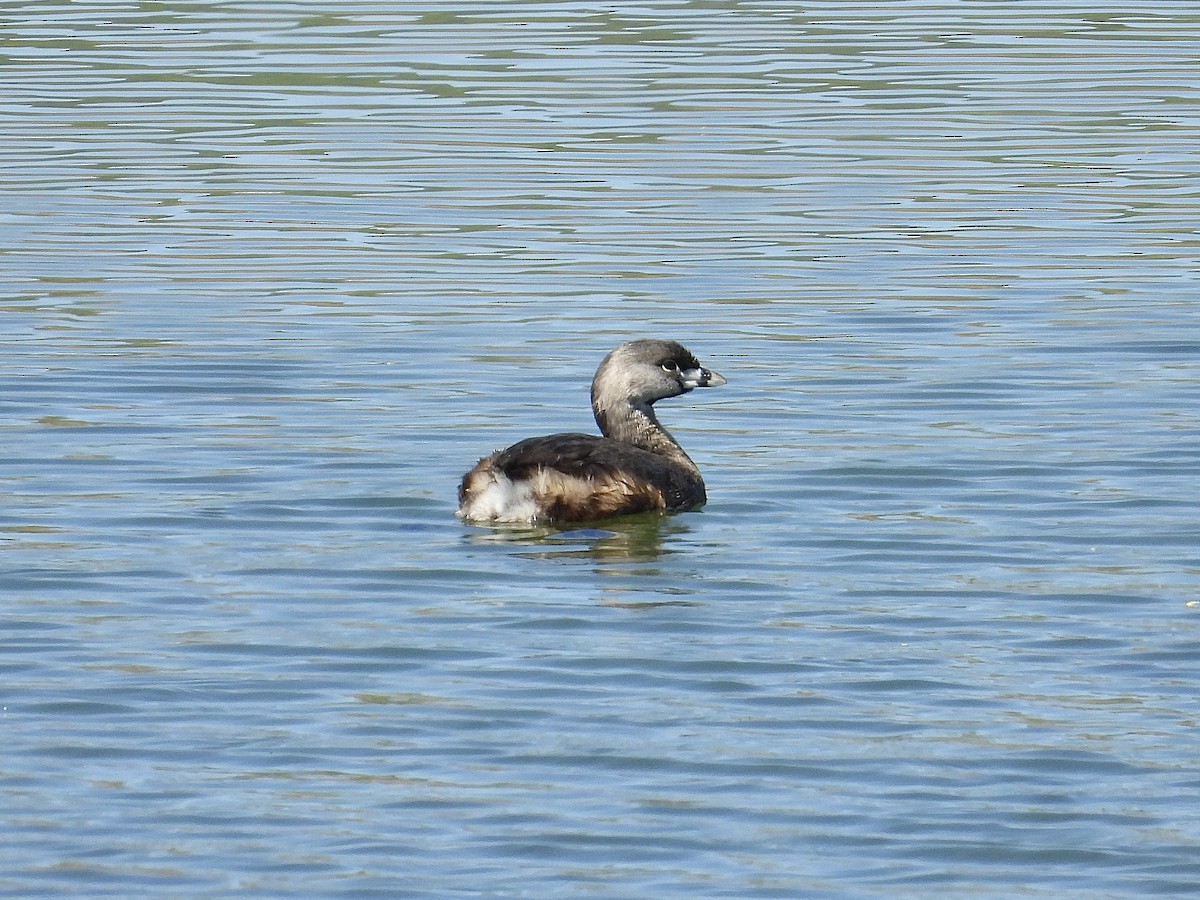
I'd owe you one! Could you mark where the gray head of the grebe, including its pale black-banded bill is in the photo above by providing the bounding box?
[592,340,725,407]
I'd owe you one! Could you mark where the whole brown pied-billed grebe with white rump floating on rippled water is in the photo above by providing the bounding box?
[456,341,725,522]
